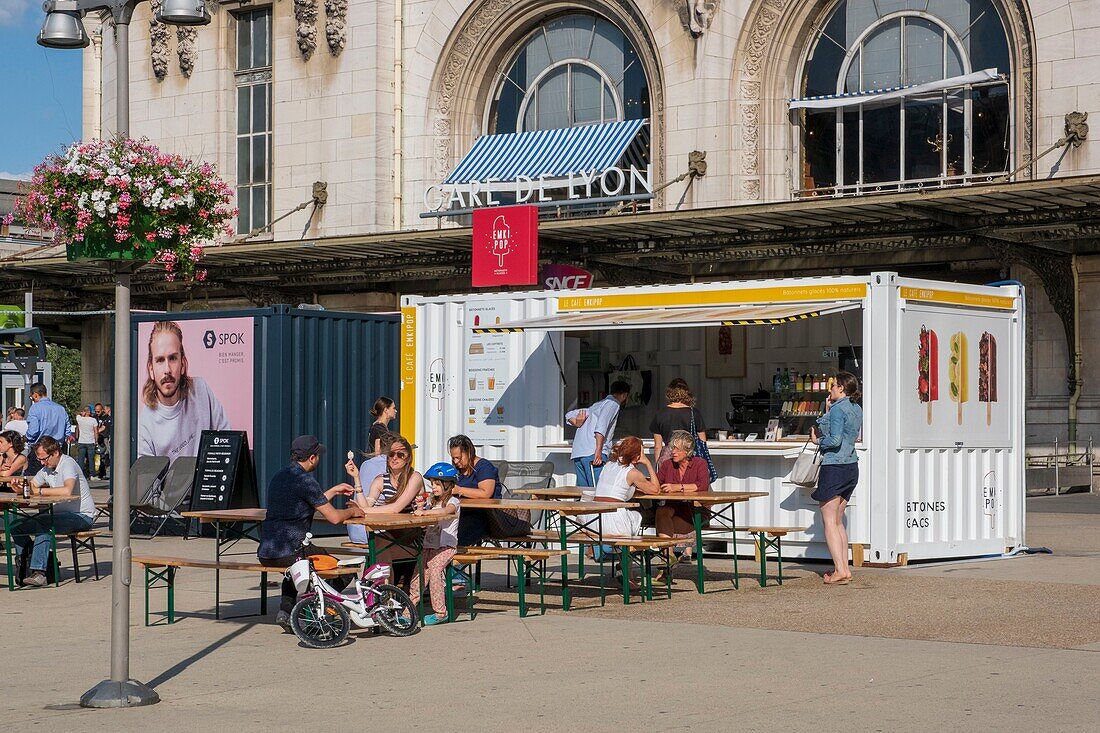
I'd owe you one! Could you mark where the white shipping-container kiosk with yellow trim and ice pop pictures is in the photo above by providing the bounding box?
[400,273,1024,564]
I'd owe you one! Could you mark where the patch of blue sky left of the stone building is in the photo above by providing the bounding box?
[0,0,81,178]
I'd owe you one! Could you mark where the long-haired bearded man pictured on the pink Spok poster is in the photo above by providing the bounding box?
[138,320,229,460]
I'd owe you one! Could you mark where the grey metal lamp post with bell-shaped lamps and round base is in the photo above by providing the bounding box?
[39,0,210,708]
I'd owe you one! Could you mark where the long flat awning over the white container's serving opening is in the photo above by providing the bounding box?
[473,300,859,333]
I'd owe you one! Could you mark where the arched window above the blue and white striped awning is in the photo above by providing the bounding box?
[488,13,649,133]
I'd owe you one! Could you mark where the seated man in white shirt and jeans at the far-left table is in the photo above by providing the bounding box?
[11,436,96,588]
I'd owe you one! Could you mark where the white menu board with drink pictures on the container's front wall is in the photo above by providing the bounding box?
[462,302,516,446]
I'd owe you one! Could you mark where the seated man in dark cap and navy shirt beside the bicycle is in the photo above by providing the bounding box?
[255,435,363,632]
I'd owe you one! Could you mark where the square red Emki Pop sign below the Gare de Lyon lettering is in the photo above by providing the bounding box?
[472,206,539,287]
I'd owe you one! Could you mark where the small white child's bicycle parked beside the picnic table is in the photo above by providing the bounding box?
[286,534,420,649]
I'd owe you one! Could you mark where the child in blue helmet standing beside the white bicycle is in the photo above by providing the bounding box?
[409,462,461,626]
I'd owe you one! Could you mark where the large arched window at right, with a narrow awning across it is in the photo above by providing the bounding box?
[798,0,1012,194]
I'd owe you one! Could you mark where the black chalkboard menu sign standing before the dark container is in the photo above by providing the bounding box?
[191,430,260,512]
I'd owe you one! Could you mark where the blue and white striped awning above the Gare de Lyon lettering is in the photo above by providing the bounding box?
[443,120,646,184]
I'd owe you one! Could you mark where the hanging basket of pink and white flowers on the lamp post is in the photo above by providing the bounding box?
[17,138,237,281]
